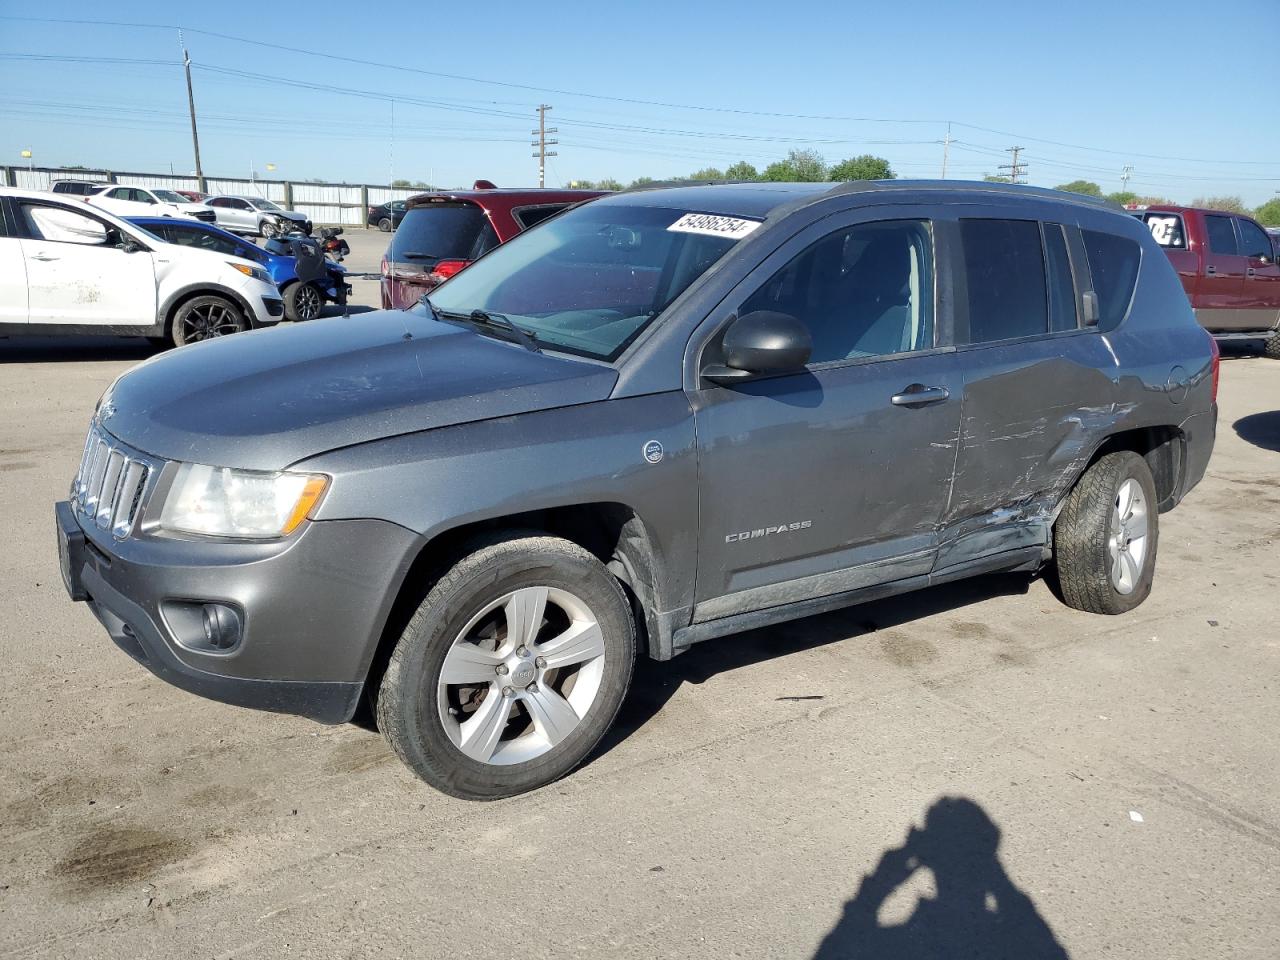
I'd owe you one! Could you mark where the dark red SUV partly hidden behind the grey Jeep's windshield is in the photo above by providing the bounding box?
[381,180,604,310]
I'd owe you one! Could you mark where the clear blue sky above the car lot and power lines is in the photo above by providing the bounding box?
[0,0,1280,205]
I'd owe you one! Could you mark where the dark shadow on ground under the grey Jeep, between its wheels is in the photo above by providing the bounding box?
[593,573,1032,758]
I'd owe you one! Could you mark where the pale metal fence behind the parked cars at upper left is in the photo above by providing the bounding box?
[0,166,422,227]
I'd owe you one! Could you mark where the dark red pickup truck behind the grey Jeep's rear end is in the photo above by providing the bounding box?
[1134,206,1280,358]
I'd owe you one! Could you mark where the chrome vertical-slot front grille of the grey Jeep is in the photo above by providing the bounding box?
[72,424,159,540]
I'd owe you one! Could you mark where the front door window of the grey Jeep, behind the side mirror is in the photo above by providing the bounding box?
[739,220,933,364]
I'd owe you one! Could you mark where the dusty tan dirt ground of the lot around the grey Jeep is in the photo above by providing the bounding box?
[0,325,1280,960]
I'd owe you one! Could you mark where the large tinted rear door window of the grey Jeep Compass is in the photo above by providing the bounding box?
[960,220,1061,343]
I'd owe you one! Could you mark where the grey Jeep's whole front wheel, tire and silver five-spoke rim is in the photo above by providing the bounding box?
[378,535,635,800]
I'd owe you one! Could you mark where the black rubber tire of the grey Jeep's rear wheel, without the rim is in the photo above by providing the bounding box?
[1053,451,1160,614]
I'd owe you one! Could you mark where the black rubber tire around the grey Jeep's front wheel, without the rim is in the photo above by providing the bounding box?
[376,532,635,800]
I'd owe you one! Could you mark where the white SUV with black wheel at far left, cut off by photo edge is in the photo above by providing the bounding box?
[0,187,284,346]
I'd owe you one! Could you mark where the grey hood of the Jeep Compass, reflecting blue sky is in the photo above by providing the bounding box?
[101,311,617,470]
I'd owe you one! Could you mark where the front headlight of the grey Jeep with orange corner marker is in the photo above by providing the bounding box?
[160,463,329,540]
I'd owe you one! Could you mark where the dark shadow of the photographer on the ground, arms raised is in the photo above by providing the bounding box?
[813,796,1069,960]
